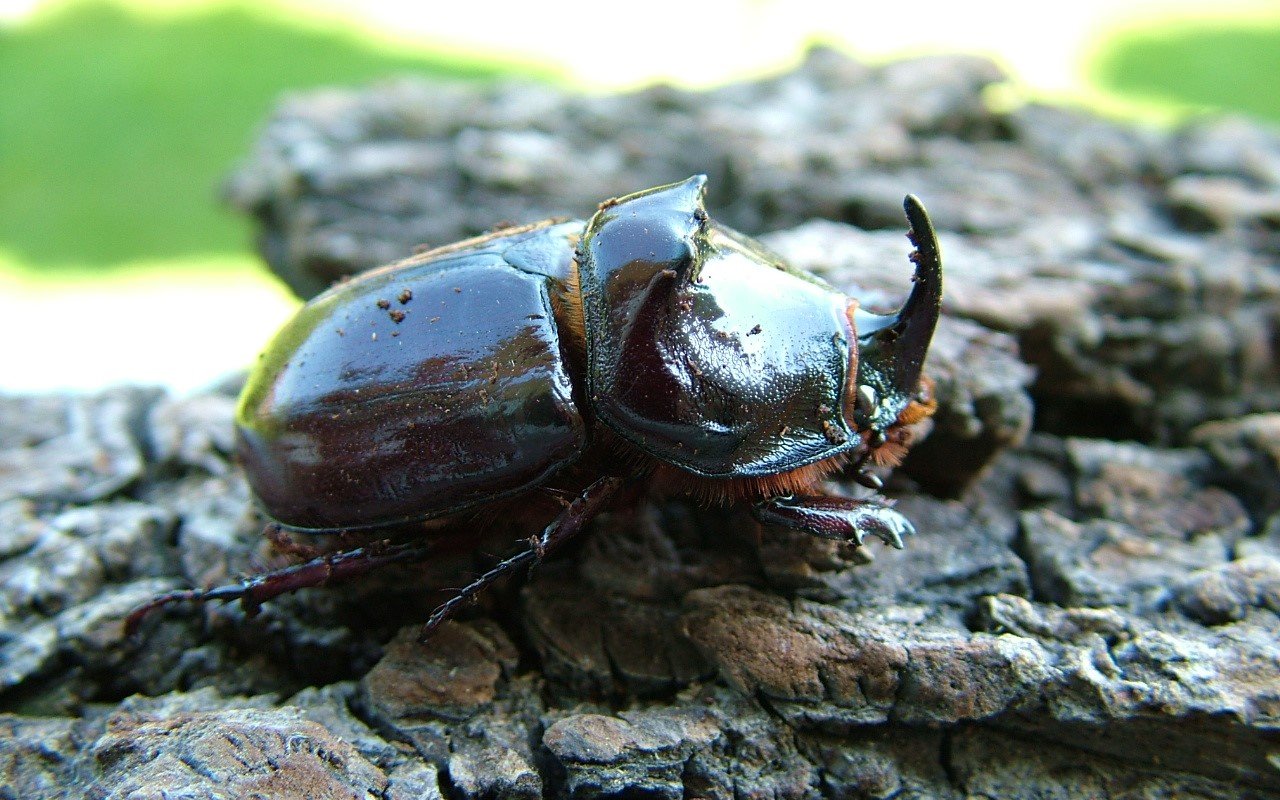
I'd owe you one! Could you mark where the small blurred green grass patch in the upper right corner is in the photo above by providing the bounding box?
[1089,15,1280,123]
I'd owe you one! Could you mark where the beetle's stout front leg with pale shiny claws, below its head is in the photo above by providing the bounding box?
[751,495,915,550]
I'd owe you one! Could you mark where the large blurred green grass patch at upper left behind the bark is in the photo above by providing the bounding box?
[0,1,552,273]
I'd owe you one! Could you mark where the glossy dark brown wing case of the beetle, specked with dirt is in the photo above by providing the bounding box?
[237,223,586,530]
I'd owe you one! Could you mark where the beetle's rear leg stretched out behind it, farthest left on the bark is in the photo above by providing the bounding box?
[124,540,431,636]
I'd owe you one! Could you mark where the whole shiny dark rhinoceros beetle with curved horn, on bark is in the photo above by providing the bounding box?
[127,175,942,635]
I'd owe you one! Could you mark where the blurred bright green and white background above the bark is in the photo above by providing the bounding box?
[0,0,1280,392]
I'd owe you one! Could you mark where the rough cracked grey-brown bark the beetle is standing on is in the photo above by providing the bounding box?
[0,51,1280,799]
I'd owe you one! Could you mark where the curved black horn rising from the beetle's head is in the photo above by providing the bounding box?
[855,195,942,431]
